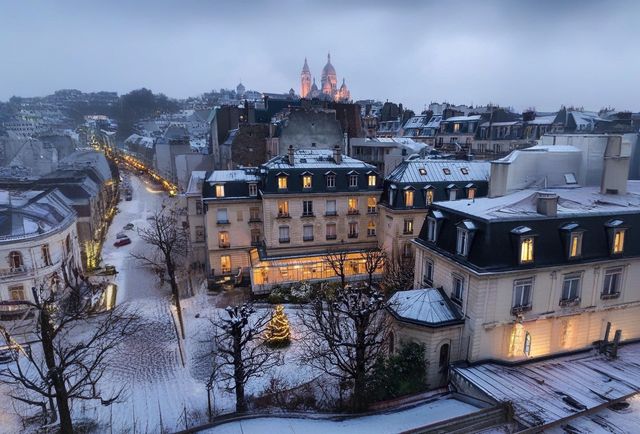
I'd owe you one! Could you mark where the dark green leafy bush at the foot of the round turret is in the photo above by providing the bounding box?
[368,343,427,402]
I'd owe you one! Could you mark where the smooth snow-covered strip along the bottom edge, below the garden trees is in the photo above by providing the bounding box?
[202,398,479,434]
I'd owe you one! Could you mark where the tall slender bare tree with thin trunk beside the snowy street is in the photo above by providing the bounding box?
[131,206,189,339]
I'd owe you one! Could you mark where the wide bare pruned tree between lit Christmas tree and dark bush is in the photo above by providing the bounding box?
[299,286,389,411]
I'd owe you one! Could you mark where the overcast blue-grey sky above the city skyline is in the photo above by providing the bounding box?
[0,0,640,111]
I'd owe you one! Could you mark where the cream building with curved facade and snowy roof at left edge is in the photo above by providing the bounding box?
[0,189,82,321]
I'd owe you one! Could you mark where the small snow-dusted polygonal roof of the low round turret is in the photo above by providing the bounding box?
[389,288,461,326]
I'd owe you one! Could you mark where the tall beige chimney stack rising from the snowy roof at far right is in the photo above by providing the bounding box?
[600,136,631,194]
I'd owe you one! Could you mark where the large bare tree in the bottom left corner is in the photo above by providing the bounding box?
[0,266,138,434]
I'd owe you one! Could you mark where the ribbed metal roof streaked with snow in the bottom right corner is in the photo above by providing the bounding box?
[453,343,640,432]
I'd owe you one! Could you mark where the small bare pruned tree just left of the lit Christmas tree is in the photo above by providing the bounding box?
[211,304,281,412]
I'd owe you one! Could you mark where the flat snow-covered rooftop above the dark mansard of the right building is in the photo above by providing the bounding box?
[437,181,640,220]
